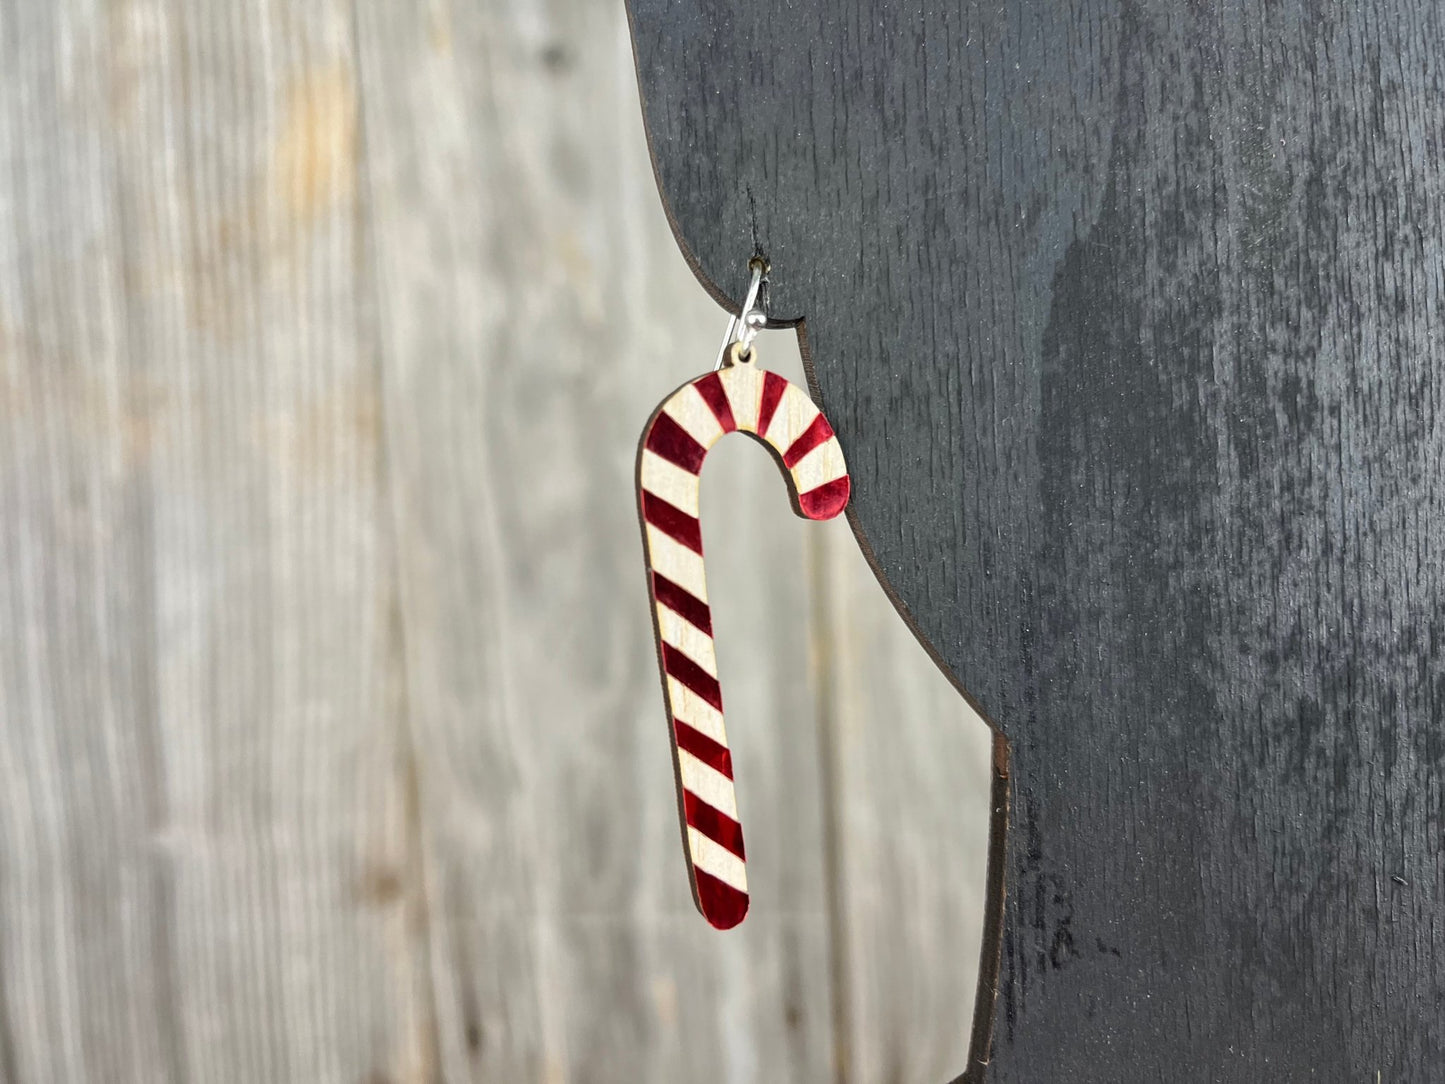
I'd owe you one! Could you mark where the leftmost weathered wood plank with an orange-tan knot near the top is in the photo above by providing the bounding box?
[0,3,420,1081]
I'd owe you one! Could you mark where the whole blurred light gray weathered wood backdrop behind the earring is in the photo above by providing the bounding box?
[0,0,988,1084]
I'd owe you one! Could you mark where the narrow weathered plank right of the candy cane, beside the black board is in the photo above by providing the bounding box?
[809,525,993,1081]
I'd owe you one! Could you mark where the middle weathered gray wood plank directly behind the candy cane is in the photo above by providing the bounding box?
[352,4,832,1081]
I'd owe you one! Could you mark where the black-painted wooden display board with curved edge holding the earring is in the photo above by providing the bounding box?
[630,0,1445,1084]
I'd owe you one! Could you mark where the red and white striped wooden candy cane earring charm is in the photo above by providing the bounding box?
[637,363,850,929]
